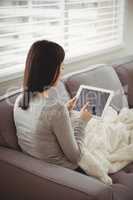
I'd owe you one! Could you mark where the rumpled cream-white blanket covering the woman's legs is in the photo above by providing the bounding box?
[79,107,133,184]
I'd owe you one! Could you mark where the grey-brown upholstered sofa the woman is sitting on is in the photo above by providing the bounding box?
[0,57,133,200]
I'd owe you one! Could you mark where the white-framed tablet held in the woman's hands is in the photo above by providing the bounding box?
[74,85,114,118]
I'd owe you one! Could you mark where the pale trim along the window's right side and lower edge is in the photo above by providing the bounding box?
[64,0,133,74]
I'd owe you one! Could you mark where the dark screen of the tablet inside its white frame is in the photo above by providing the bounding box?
[74,88,110,117]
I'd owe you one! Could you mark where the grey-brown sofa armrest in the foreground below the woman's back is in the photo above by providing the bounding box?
[0,147,112,200]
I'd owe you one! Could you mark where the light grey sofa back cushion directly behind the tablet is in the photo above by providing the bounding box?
[64,65,128,110]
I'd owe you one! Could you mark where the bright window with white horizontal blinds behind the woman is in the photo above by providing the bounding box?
[0,0,124,71]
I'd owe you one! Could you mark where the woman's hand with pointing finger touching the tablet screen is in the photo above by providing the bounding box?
[80,102,92,122]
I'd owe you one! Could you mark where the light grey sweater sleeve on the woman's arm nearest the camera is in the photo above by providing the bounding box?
[52,104,87,164]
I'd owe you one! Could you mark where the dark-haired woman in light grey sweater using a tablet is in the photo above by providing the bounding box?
[14,40,91,172]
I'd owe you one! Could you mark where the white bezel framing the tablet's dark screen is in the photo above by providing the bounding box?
[75,85,114,119]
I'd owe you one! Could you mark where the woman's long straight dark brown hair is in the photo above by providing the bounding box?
[19,40,65,110]
